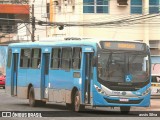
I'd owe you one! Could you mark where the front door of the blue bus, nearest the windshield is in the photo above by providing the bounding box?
[84,53,93,104]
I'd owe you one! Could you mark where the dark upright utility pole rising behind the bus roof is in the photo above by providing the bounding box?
[31,4,35,42]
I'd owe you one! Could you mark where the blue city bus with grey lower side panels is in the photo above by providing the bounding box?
[6,39,151,113]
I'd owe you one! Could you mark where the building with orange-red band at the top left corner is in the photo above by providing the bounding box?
[0,0,30,43]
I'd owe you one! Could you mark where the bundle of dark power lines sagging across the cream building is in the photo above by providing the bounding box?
[1,0,159,39]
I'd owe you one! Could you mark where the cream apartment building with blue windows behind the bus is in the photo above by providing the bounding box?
[50,0,160,75]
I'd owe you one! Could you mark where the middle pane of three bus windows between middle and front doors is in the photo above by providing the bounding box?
[62,48,72,70]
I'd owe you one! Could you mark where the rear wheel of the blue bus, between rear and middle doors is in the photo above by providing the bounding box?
[29,87,38,107]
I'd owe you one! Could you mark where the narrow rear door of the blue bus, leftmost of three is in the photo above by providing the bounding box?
[11,53,19,96]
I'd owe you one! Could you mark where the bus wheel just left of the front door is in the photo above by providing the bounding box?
[74,91,85,112]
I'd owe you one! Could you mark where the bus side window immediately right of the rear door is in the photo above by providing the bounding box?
[20,49,31,68]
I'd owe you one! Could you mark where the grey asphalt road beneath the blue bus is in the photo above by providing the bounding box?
[0,88,160,120]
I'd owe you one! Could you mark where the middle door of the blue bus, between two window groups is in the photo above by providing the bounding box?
[41,53,50,99]
